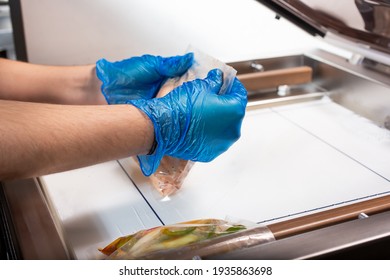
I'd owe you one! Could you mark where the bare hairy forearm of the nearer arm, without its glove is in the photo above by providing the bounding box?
[0,101,154,180]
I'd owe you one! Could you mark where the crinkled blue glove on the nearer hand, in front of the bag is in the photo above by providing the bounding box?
[128,69,247,176]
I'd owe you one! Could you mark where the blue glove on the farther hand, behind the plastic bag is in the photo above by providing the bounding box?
[96,53,194,104]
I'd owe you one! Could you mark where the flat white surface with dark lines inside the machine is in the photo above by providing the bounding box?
[42,98,390,258]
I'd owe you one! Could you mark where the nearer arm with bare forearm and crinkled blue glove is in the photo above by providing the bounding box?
[0,61,246,180]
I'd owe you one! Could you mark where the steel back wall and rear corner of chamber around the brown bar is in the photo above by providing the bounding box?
[230,50,390,128]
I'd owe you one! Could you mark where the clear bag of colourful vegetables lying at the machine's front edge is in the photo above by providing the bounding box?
[99,219,274,260]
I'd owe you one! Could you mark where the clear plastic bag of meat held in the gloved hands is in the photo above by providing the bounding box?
[150,47,237,197]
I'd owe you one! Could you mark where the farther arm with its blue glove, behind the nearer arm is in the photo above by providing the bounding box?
[0,53,193,105]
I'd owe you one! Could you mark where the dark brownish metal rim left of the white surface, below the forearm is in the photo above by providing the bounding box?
[3,179,70,260]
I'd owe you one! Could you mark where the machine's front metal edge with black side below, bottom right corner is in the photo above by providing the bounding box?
[207,212,390,260]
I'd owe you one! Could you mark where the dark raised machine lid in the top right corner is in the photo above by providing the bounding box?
[257,0,390,54]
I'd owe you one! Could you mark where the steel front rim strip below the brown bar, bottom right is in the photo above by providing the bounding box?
[213,212,390,259]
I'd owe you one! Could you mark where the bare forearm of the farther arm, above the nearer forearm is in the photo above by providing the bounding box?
[0,59,106,105]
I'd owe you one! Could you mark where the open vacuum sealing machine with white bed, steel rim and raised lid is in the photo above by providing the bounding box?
[2,0,390,259]
